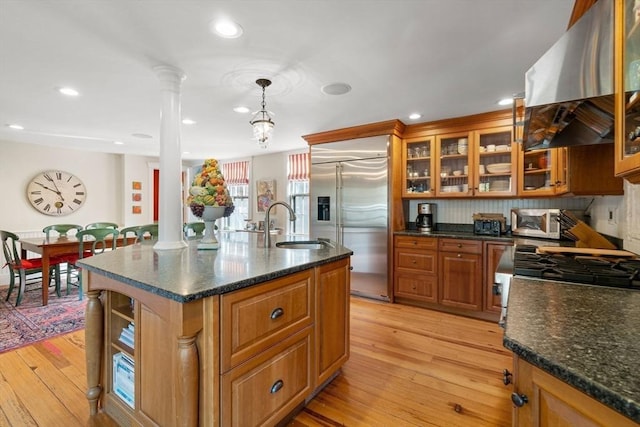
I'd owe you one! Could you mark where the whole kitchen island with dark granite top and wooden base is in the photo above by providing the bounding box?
[80,233,352,426]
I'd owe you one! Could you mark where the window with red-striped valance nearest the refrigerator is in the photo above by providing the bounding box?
[287,153,309,234]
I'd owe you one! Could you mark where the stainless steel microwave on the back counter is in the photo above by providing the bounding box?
[511,209,562,240]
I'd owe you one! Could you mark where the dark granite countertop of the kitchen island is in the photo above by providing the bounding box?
[79,233,353,303]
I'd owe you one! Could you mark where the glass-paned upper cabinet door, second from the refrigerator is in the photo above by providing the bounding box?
[436,132,473,197]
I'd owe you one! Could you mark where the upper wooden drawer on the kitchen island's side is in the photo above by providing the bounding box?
[220,270,313,372]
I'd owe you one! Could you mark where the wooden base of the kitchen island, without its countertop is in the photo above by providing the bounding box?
[86,258,350,427]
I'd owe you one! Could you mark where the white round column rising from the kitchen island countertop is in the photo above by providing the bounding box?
[153,65,187,250]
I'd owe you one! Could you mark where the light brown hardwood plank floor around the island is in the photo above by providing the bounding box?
[0,297,511,427]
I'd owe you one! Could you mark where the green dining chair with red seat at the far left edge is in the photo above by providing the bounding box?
[0,230,66,307]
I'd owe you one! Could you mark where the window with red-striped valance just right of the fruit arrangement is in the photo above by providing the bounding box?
[221,161,249,230]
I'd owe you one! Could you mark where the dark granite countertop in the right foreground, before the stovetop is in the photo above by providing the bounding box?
[504,277,640,422]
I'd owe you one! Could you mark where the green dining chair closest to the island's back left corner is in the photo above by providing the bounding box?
[67,228,120,299]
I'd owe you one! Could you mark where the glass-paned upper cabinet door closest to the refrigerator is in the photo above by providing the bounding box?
[402,139,434,197]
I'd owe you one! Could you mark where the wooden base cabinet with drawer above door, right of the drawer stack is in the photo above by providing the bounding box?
[438,239,483,311]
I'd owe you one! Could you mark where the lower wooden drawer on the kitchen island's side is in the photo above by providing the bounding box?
[220,327,312,427]
